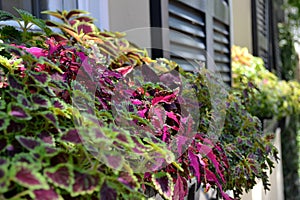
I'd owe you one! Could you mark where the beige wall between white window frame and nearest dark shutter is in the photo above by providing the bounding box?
[108,0,151,48]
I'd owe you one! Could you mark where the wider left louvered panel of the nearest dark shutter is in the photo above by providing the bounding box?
[169,1,206,71]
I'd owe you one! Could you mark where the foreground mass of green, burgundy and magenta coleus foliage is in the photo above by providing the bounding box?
[0,10,276,199]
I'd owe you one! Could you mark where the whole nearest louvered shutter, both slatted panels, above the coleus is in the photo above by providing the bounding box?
[164,0,231,85]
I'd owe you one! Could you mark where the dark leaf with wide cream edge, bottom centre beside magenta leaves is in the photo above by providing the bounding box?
[152,172,174,199]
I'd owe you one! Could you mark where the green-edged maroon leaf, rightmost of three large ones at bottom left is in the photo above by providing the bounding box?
[71,170,102,196]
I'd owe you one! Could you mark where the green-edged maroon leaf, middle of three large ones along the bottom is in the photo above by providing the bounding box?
[44,164,74,192]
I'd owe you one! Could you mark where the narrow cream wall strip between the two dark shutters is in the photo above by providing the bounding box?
[232,0,252,53]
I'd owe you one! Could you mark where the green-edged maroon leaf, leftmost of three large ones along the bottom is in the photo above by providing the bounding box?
[11,163,49,189]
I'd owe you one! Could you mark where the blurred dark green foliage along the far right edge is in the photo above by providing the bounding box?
[279,0,300,199]
